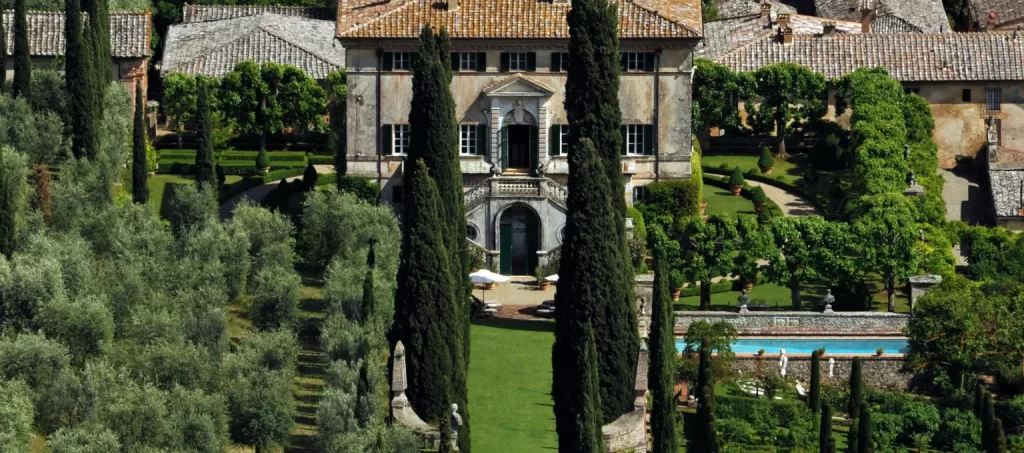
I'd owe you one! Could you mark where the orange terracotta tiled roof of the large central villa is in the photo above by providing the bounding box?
[338,0,700,39]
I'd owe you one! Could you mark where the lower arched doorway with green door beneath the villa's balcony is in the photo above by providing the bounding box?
[498,205,541,276]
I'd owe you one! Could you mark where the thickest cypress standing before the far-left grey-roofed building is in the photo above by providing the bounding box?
[65,0,97,158]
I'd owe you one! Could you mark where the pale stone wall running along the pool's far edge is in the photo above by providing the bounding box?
[675,311,910,335]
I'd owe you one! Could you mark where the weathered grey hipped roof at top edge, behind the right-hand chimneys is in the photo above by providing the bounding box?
[814,0,950,33]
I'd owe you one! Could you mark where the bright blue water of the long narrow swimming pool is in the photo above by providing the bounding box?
[676,337,907,355]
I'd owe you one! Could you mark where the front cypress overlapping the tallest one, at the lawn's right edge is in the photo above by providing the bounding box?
[551,139,606,453]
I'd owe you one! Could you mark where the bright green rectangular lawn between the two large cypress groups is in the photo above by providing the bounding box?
[469,319,558,453]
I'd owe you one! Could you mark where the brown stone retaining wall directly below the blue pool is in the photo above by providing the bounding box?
[734,354,912,390]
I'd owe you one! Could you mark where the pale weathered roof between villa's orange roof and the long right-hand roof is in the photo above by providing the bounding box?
[696,13,861,58]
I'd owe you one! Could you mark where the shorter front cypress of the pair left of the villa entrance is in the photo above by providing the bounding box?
[392,160,454,422]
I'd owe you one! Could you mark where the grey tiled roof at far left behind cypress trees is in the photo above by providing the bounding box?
[3,9,152,58]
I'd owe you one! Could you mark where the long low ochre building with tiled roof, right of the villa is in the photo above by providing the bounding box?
[714,32,1024,168]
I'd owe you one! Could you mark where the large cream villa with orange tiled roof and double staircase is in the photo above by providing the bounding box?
[337,0,701,275]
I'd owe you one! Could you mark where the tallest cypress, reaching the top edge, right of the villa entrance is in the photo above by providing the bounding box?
[559,0,639,422]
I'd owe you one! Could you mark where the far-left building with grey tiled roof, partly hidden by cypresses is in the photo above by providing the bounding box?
[3,9,153,95]
